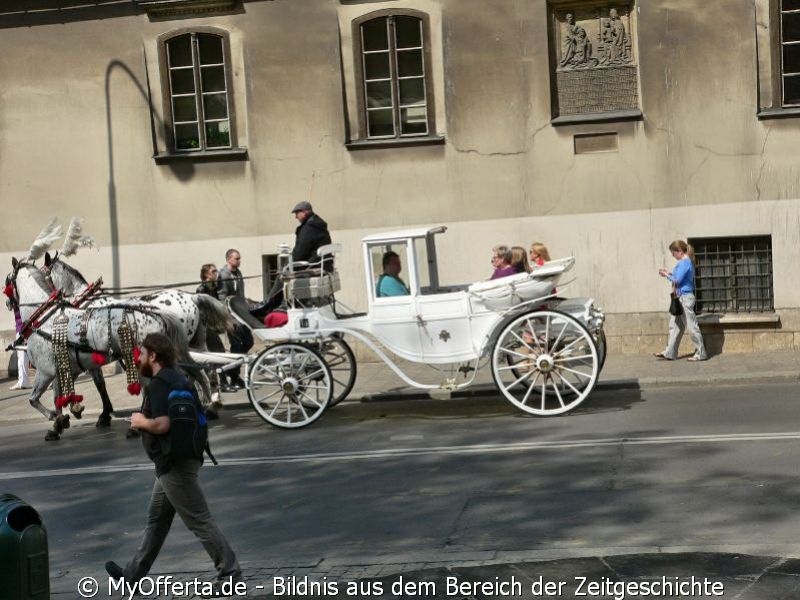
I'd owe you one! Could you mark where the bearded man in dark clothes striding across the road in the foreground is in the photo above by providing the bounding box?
[106,333,242,585]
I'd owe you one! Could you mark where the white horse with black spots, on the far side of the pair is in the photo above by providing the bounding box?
[43,252,233,418]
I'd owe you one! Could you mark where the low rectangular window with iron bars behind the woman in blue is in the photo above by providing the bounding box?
[689,235,774,313]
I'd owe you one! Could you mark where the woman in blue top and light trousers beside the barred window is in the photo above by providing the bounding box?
[655,240,708,362]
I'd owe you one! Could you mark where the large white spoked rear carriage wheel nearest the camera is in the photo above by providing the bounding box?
[492,310,600,416]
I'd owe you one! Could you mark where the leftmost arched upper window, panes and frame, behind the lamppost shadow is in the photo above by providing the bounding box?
[164,32,233,152]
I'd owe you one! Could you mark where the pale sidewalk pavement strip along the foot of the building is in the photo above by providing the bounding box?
[0,351,800,424]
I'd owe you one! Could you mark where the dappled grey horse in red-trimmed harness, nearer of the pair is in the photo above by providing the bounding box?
[6,259,189,441]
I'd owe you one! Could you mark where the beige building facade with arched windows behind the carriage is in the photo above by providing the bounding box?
[0,0,800,372]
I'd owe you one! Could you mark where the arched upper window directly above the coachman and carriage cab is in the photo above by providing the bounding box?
[359,15,430,139]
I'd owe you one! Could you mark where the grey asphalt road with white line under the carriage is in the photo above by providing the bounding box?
[0,383,800,591]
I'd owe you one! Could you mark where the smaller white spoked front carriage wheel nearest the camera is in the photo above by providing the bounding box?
[247,343,333,429]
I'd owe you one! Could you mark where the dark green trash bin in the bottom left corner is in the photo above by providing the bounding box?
[0,494,50,600]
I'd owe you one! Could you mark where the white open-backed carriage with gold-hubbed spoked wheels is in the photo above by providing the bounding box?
[190,227,606,428]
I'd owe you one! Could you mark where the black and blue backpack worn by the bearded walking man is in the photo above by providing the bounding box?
[155,380,217,465]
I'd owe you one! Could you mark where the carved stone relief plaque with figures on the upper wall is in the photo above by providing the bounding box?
[551,2,639,117]
